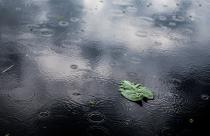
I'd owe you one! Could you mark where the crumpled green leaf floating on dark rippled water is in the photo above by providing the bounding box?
[119,80,154,101]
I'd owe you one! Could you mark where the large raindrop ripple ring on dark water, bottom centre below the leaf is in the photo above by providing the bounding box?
[88,111,105,123]
